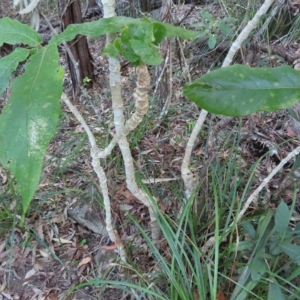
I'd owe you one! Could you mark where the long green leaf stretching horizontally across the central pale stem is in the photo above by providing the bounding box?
[52,17,196,44]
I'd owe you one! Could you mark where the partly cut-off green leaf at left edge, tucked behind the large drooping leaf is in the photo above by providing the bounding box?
[0,48,29,94]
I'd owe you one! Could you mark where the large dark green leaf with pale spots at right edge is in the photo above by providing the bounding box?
[183,65,300,117]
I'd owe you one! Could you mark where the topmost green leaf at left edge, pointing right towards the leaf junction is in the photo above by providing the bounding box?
[0,18,42,47]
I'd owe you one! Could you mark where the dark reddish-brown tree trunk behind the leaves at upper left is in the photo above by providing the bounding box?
[58,0,94,95]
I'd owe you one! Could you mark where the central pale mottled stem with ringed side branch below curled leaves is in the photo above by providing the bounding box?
[100,0,160,240]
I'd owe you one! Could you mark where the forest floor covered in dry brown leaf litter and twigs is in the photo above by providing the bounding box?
[0,1,300,300]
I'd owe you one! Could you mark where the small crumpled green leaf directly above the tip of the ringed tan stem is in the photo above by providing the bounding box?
[130,40,162,66]
